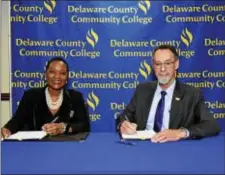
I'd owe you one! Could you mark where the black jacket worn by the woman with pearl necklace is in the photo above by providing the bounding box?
[4,88,90,133]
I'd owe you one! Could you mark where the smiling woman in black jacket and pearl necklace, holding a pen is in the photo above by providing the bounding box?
[1,57,90,138]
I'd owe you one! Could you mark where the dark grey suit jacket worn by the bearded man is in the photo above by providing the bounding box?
[116,81,220,138]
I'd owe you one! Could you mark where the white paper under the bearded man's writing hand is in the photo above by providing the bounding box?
[122,130,156,139]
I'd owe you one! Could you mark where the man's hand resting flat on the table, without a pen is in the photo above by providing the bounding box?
[151,129,187,143]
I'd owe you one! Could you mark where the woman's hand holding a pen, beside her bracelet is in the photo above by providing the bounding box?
[42,123,63,135]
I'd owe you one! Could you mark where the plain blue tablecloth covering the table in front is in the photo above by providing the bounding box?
[1,133,225,174]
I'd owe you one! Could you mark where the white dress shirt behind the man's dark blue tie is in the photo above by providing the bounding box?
[146,80,176,131]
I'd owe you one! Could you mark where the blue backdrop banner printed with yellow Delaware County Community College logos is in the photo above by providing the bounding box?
[11,0,225,132]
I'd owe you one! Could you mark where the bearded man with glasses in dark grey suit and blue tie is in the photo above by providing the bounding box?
[117,45,220,143]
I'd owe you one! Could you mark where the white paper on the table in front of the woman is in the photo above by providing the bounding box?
[7,131,47,140]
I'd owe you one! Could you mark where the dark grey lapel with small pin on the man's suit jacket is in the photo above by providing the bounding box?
[169,81,184,129]
